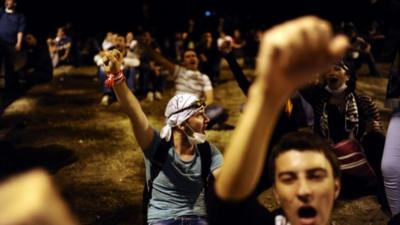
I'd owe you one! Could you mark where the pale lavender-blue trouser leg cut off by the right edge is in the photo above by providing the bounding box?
[381,108,400,215]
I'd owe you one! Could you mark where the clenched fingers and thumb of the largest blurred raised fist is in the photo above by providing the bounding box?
[258,16,348,79]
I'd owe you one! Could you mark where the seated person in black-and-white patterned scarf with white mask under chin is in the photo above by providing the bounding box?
[308,61,385,195]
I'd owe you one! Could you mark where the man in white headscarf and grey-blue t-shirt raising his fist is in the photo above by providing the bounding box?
[103,50,223,225]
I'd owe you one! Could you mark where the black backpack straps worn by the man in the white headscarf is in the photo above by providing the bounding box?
[142,139,211,225]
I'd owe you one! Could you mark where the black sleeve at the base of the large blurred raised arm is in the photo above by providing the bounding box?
[206,181,275,225]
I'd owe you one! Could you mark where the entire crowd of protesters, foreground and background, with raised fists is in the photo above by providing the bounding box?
[0,0,400,225]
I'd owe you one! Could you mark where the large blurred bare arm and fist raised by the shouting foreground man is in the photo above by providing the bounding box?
[215,17,347,201]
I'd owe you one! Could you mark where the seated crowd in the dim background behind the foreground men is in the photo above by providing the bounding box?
[0,0,400,225]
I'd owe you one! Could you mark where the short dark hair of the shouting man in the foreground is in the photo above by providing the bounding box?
[268,131,340,183]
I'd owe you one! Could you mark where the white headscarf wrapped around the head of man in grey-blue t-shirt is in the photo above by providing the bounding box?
[160,94,201,141]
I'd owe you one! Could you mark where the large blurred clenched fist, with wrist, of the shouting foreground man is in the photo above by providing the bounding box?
[256,16,348,96]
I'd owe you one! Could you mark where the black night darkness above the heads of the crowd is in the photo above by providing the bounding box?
[14,0,396,40]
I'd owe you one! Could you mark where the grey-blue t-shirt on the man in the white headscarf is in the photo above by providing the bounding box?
[144,132,223,224]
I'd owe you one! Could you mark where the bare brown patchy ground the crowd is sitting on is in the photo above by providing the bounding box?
[0,64,388,225]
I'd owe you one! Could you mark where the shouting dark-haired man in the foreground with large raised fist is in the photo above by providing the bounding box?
[207,16,348,225]
